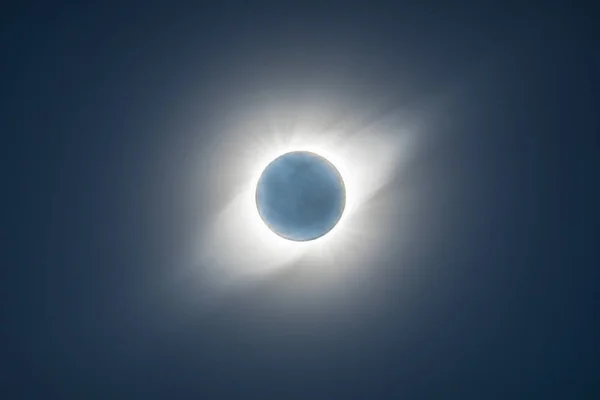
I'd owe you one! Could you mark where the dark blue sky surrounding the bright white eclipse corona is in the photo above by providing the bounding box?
[0,1,600,399]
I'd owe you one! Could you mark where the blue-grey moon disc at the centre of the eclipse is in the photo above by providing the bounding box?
[256,151,346,242]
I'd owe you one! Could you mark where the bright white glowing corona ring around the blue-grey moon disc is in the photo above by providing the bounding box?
[196,93,412,294]
